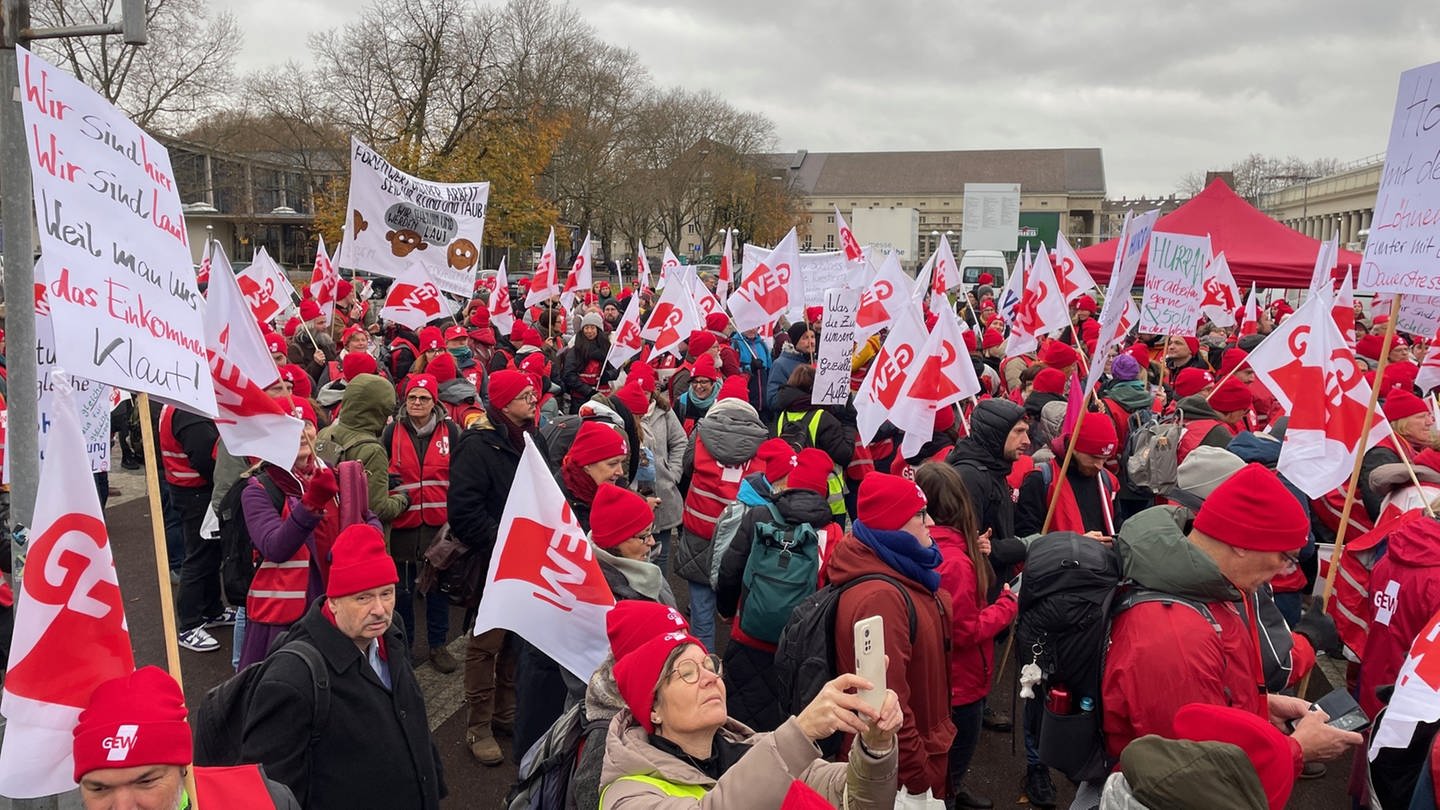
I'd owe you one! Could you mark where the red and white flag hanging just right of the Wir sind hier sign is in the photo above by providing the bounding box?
[204,245,305,470]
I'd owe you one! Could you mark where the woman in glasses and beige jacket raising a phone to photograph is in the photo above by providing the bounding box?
[600,616,903,810]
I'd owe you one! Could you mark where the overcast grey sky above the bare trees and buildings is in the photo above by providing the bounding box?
[215,0,1440,196]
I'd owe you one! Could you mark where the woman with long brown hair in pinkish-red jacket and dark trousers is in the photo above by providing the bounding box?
[914,461,1018,809]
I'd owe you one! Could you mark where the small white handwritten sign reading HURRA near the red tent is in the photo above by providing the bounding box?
[1140,231,1211,334]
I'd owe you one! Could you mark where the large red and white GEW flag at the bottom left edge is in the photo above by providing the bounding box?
[0,372,135,798]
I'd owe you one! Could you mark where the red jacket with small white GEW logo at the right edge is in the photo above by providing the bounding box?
[1359,517,1440,716]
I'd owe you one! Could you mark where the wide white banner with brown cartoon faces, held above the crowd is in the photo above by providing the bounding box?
[343,138,490,298]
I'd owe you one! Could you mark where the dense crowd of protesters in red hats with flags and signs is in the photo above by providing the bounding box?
[0,18,1440,810]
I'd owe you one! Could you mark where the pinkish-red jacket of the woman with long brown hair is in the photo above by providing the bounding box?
[930,526,1020,706]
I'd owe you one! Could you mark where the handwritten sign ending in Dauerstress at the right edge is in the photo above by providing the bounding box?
[1355,62,1440,292]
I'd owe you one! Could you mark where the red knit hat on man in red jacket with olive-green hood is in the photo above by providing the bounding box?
[1195,463,1310,551]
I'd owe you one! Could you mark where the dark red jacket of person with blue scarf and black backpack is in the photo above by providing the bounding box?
[828,533,955,798]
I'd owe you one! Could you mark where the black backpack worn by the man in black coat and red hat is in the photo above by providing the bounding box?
[192,636,330,765]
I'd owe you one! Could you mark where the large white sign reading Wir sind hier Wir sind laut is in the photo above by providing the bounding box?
[16,48,215,417]
